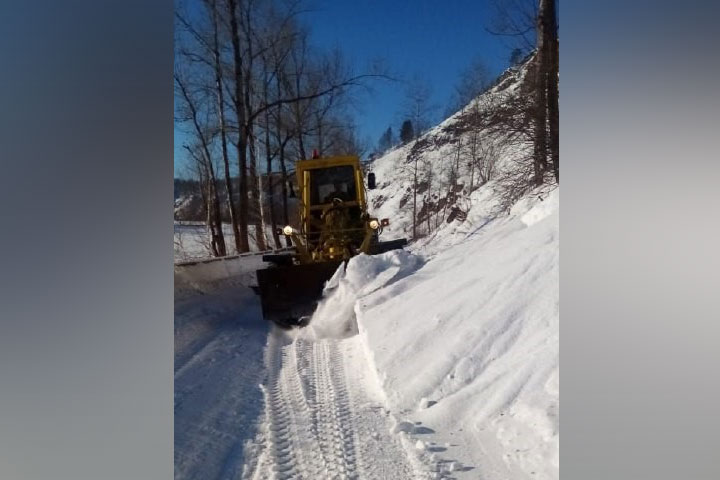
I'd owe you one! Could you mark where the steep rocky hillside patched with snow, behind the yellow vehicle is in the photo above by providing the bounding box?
[367,60,532,249]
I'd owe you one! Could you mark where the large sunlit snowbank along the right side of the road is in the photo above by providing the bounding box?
[307,190,559,479]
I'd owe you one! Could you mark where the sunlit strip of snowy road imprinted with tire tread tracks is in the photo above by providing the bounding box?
[244,335,420,480]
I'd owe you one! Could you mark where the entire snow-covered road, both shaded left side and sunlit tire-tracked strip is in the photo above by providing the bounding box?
[175,288,423,480]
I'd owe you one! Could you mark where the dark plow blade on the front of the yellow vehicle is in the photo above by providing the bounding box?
[257,262,342,329]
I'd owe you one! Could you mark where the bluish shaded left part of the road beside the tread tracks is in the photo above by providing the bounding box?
[174,288,269,479]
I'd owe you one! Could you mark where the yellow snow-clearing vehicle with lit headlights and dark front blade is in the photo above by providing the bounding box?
[257,154,407,328]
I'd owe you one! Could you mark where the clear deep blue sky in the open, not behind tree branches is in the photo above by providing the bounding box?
[175,0,510,176]
